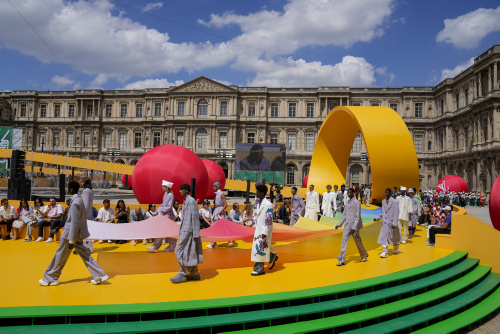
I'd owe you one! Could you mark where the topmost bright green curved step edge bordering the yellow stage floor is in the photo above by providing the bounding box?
[0,251,468,319]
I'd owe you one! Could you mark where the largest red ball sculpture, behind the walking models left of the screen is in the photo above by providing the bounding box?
[132,145,208,204]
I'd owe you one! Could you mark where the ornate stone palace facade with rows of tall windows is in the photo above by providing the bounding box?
[0,45,500,192]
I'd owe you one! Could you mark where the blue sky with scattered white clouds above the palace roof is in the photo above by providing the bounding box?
[0,0,500,91]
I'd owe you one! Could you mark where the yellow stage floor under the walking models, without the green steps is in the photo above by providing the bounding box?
[0,223,453,312]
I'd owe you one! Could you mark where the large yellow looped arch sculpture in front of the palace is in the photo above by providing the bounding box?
[307,107,419,202]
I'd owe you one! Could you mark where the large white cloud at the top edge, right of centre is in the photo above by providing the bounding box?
[198,0,392,54]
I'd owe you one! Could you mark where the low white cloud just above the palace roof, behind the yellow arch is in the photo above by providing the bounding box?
[249,56,375,87]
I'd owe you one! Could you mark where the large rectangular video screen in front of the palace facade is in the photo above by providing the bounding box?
[235,143,286,172]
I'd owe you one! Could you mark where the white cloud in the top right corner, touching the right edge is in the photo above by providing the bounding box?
[436,7,500,49]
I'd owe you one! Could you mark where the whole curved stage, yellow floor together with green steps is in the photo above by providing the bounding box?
[0,210,500,334]
